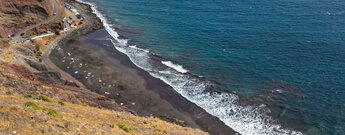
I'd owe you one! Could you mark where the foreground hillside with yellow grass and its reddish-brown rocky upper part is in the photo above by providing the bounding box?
[0,63,204,135]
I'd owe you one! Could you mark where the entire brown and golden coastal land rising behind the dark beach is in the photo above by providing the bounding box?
[0,0,207,135]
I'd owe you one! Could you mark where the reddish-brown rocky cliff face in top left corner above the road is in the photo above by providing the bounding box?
[0,0,53,38]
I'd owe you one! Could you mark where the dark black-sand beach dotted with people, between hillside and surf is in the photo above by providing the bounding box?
[49,29,236,135]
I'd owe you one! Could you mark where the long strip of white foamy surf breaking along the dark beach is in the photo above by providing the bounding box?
[77,0,302,135]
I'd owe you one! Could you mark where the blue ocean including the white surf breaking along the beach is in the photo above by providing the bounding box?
[76,0,345,135]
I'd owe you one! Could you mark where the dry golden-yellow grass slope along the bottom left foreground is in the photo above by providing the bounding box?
[0,95,206,135]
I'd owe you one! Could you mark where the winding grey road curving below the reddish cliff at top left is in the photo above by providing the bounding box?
[13,0,59,42]
